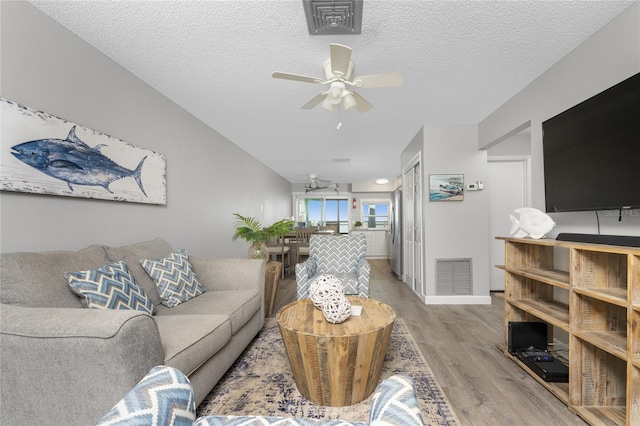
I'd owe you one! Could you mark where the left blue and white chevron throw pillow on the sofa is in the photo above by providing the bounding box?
[64,261,156,315]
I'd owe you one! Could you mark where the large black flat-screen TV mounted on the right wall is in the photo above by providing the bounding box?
[542,73,640,212]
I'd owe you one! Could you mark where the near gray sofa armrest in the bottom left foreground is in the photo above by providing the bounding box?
[0,304,163,425]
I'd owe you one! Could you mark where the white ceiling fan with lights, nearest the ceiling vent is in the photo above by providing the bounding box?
[273,43,402,112]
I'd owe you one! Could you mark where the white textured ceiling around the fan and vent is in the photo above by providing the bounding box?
[30,0,632,183]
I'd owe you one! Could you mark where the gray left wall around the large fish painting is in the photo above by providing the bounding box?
[0,1,292,257]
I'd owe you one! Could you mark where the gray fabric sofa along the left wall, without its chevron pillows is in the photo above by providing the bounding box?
[0,239,265,425]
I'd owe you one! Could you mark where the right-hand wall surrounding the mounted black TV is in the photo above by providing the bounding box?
[478,2,640,237]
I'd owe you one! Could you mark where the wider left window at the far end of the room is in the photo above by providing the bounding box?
[298,197,349,234]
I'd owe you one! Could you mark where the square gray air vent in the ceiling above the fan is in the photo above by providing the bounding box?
[302,0,362,35]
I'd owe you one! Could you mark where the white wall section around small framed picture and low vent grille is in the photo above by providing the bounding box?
[402,125,491,304]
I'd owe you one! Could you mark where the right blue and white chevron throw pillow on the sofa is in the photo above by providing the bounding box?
[140,249,204,308]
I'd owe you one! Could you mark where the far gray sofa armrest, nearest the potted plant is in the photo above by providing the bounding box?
[189,256,265,292]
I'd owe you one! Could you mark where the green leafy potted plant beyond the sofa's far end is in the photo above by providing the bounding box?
[232,213,293,262]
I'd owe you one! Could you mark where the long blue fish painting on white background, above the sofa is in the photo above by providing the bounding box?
[0,98,167,204]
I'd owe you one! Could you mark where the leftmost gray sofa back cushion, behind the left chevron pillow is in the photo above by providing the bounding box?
[0,245,109,308]
